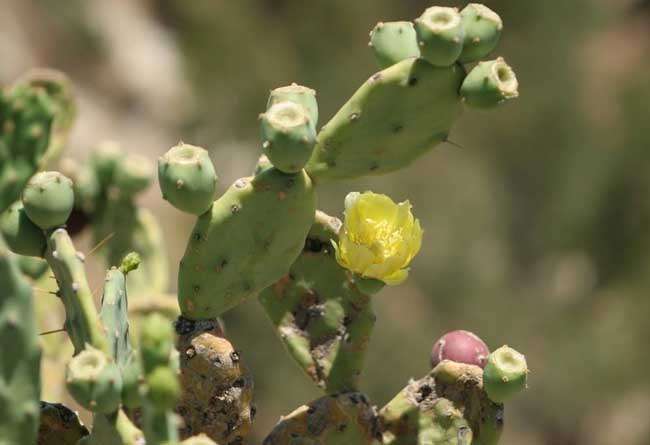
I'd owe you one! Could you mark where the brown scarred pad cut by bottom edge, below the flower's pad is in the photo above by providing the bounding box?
[263,392,378,445]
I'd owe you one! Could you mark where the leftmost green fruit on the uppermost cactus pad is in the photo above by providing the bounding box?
[370,22,420,69]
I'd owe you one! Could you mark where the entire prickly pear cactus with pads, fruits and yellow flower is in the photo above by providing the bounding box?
[0,4,528,445]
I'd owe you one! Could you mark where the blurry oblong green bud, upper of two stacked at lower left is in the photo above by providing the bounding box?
[140,314,174,375]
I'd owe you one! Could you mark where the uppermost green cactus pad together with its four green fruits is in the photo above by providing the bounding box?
[306,4,518,182]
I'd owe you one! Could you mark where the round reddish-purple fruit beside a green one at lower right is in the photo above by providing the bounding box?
[431,330,490,368]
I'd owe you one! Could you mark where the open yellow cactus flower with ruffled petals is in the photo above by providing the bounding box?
[334,192,422,285]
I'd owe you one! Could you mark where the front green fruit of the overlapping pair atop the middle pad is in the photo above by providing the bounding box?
[260,101,316,173]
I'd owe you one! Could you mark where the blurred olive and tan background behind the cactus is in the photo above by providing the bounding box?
[0,0,650,445]
